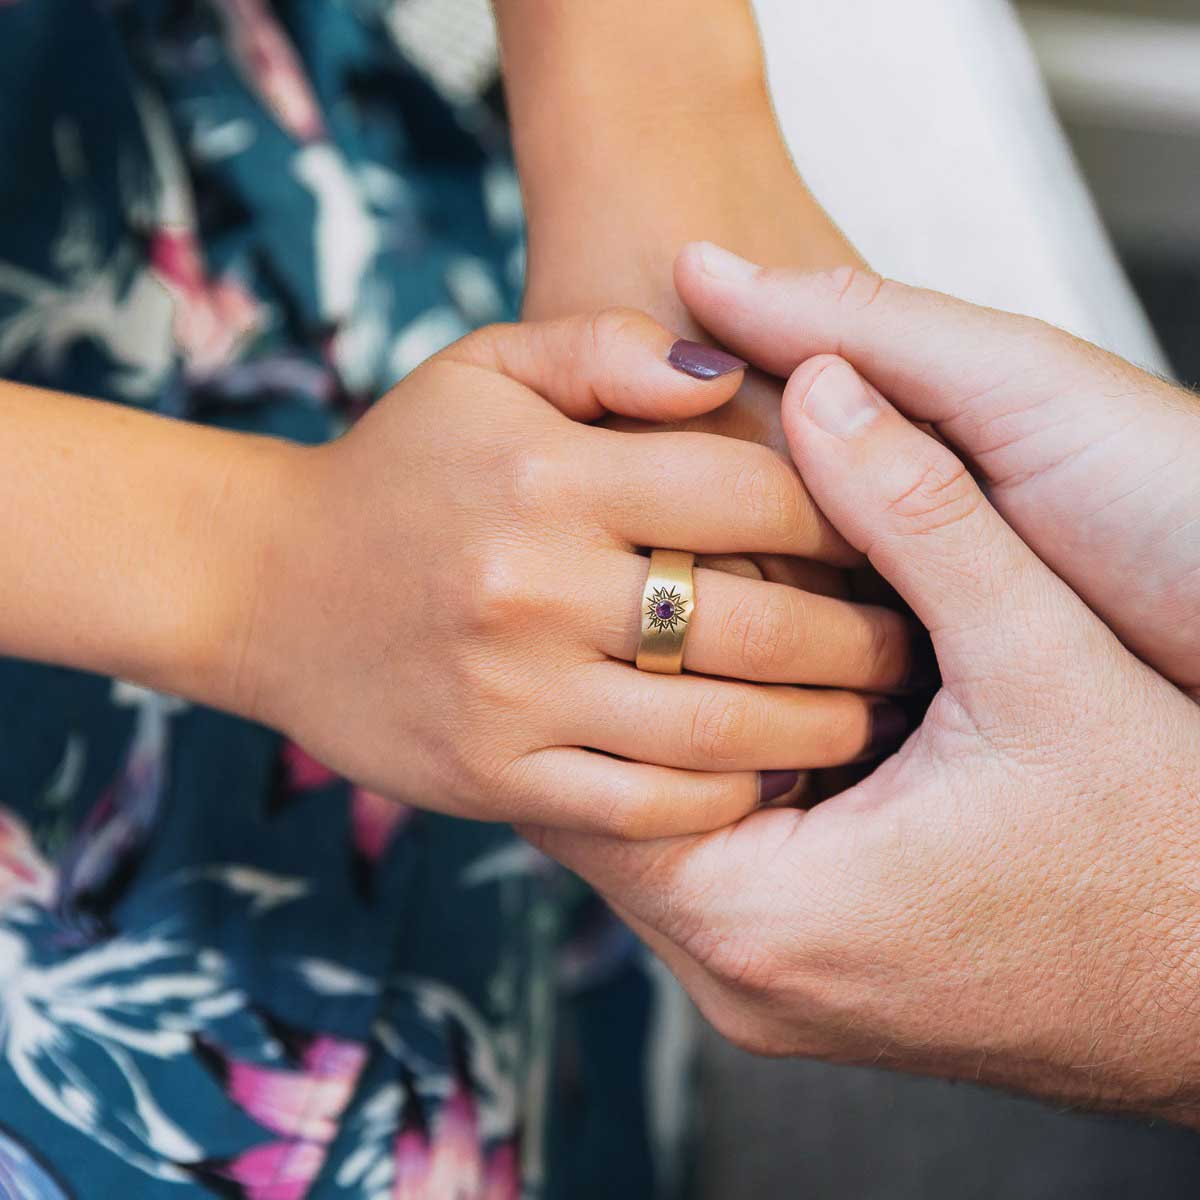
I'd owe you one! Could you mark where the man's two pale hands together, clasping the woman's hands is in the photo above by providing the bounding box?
[529,247,1200,1127]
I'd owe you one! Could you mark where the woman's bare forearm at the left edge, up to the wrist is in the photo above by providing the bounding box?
[0,382,283,707]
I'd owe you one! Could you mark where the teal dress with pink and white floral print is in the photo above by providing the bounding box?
[0,0,686,1200]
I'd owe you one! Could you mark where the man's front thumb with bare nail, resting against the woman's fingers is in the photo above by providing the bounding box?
[784,355,1081,683]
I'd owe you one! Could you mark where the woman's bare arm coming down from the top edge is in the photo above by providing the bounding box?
[496,0,859,325]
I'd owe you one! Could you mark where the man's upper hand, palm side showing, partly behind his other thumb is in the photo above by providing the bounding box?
[677,246,1200,689]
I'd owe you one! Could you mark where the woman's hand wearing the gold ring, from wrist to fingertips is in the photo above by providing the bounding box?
[233,311,910,836]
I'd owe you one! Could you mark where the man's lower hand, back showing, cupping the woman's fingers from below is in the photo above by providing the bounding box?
[530,324,1200,1122]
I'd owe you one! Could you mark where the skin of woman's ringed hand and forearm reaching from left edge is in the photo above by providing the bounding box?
[0,311,910,838]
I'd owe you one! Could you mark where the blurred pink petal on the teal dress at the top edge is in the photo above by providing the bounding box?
[221,0,325,142]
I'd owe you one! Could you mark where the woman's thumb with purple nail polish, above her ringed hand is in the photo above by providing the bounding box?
[445,308,746,422]
